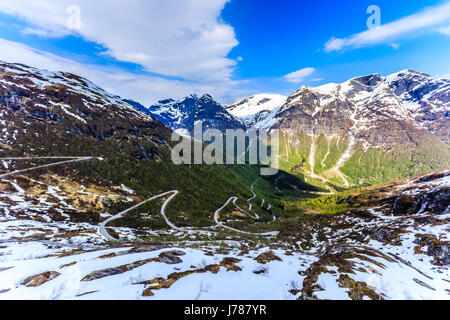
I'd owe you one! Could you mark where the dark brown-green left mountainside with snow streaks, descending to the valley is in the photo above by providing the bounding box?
[0,63,298,224]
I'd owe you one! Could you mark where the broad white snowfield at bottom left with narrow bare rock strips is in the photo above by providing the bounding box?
[0,243,315,299]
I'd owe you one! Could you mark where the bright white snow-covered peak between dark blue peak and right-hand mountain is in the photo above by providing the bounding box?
[227,93,287,128]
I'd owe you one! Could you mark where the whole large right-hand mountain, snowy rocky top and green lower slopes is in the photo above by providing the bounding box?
[232,70,450,186]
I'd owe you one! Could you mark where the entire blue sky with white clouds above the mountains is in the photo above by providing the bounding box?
[0,0,450,105]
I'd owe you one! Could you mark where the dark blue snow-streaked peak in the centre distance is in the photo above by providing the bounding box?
[148,94,246,133]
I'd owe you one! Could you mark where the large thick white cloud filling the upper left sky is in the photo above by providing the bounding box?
[0,0,238,83]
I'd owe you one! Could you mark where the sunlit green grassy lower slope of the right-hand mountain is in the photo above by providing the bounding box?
[280,131,450,189]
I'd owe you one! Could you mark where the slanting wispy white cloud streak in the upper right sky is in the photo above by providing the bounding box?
[325,2,450,52]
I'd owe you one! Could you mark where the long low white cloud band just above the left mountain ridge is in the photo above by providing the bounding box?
[0,39,248,106]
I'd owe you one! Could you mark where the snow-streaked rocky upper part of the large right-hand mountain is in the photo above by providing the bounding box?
[274,71,450,146]
